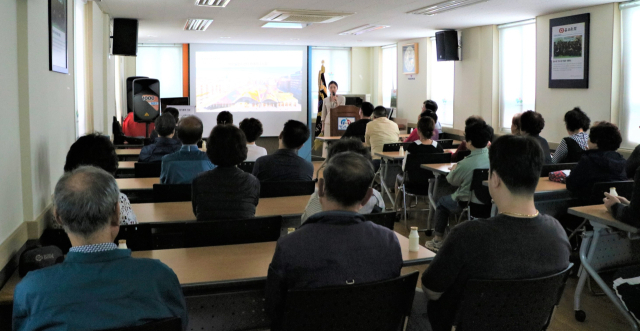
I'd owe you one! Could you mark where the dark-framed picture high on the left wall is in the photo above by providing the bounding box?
[48,0,69,74]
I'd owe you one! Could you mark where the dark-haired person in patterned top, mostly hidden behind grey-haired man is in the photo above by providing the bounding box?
[51,133,138,229]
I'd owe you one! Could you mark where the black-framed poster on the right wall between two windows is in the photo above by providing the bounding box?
[549,14,590,88]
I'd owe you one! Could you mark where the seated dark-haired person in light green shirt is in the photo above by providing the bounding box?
[425,121,493,251]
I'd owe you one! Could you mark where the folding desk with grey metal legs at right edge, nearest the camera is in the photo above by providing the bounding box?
[569,205,640,330]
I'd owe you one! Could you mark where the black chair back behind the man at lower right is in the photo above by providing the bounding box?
[454,264,573,331]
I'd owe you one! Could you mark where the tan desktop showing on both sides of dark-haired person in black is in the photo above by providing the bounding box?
[131,195,310,223]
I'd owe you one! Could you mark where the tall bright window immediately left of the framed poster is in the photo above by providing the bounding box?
[498,20,536,131]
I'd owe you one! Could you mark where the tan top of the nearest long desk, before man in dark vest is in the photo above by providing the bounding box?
[0,233,435,304]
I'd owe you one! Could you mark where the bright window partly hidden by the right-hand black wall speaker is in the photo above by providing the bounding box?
[429,38,455,126]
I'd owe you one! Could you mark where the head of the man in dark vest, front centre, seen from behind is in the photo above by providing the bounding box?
[318,152,375,212]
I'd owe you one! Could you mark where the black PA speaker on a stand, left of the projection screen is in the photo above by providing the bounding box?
[132,78,160,138]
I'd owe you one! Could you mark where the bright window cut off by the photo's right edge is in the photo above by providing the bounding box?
[620,1,640,148]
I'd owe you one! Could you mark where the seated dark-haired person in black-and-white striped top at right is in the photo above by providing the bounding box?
[553,107,591,163]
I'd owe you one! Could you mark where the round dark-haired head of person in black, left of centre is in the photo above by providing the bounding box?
[207,125,247,167]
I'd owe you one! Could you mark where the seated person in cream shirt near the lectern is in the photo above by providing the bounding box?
[364,106,400,169]
